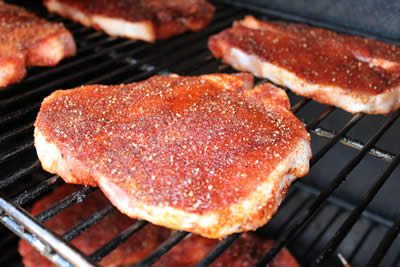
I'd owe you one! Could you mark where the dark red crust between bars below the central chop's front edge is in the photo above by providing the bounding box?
[154,234,299,267]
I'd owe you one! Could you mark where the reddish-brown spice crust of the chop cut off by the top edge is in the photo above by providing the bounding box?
[44,0,215,39]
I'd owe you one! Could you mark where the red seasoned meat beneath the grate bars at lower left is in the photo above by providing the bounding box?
[19,185,169,267]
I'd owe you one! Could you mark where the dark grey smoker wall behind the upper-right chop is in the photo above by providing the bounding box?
[225,0,400,41]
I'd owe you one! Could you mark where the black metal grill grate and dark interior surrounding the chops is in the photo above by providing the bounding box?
[0,1,400,266]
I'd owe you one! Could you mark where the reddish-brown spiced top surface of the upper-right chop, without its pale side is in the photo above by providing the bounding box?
[209,16,400,95]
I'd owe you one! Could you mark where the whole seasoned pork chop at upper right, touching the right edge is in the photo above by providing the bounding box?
[209,17,400,114]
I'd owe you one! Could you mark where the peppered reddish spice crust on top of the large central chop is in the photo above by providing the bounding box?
[35,74,309,216]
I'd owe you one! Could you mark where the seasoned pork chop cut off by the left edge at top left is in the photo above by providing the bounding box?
[0,1,76,87]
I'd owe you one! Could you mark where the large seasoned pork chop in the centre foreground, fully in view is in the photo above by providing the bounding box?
[35,74,311,238]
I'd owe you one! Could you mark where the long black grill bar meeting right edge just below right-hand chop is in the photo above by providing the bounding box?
[257,112,400,266]
